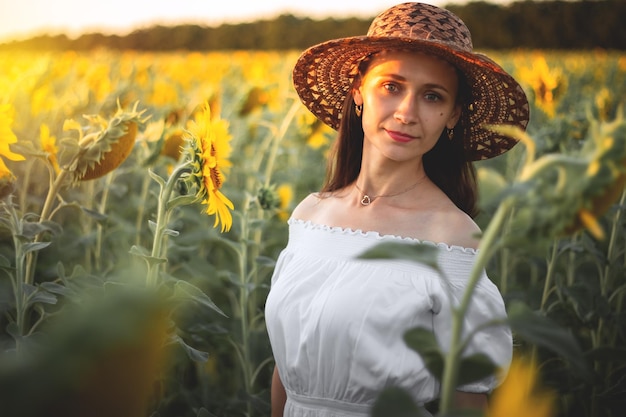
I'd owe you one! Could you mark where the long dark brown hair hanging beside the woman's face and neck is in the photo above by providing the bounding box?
[322,58,478,217]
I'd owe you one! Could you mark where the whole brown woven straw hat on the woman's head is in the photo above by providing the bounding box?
[293,3,529,160]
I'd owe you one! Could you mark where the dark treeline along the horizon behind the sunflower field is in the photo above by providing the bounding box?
[0,0,626,51]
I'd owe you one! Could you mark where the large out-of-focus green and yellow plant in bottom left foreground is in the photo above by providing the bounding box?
[0,285,170,417]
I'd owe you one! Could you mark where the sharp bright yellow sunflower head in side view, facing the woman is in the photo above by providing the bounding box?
[185,103,234,232]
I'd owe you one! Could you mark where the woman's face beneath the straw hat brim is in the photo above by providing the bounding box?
[354,51,461,162]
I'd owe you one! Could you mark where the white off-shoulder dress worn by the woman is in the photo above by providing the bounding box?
[265,219,512,417]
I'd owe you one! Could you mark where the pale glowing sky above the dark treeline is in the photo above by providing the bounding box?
[0,0,508,42]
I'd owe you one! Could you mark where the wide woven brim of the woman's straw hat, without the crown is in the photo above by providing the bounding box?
[293,36,530,160]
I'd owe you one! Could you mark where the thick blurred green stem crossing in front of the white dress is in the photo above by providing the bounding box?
[440,199,513,415]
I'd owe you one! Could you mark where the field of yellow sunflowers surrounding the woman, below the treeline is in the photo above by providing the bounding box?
[0,50,626,417]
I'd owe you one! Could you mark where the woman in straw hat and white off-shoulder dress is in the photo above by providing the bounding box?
[266,3,529,417]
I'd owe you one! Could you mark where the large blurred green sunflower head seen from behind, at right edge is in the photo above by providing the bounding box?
[492,115,626,241]
